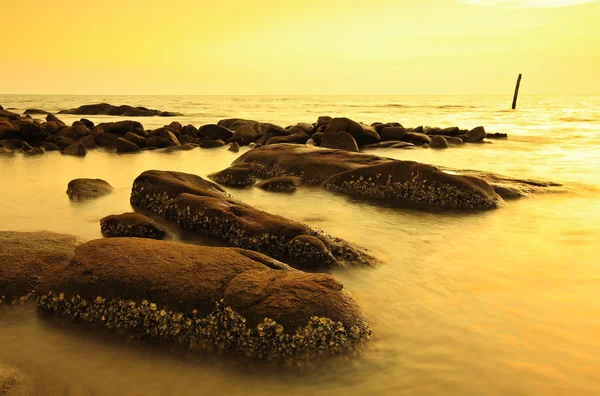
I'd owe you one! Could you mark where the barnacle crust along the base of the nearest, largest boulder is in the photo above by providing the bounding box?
[38,292,371,361]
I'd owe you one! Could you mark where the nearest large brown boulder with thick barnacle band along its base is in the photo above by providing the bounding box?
[39,238,371,359]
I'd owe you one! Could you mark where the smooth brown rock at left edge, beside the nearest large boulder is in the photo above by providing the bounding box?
[0,231,81,302]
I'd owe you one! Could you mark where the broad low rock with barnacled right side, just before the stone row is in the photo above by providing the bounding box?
[234,145,503,210]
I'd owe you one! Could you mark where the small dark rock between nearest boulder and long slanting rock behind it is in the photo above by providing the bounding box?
[100,212,167,239]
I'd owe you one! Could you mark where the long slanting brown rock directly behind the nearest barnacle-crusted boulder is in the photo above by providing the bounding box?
[131,171,374,267]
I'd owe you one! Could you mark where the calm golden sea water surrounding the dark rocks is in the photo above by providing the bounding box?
[0,95,600,396]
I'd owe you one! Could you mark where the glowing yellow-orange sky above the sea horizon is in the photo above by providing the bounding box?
[0,0,600,95]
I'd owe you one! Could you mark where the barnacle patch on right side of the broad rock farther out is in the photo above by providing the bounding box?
[326,172,501,209]
